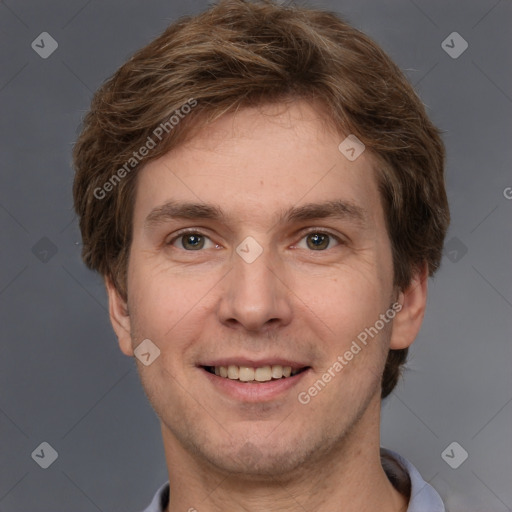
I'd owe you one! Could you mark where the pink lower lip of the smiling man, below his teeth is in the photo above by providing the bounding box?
[201,368,310,402]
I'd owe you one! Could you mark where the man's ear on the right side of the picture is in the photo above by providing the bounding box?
[389,264,428,350]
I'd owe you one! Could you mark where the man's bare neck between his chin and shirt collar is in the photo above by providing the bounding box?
[162,401,408,512]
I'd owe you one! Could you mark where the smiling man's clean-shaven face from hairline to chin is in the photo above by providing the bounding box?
[109,102,422,475]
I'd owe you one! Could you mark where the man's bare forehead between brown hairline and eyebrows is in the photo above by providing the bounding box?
[134,101,382,228]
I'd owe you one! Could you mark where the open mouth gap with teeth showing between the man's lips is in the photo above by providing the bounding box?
[202,364,310,384]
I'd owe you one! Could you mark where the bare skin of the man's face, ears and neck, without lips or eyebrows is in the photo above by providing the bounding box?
[107,100,427,512]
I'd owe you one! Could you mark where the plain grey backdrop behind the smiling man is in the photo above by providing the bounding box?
[0,0,512,512]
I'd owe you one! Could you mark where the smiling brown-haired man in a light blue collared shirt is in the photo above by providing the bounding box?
[74,0,449,512]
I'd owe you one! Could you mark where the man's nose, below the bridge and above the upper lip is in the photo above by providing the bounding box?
[218,250,292,332]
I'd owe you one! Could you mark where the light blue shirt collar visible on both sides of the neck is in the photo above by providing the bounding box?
[139,449,445,512]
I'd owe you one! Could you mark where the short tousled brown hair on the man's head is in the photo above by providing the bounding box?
[73,0,449,397]
